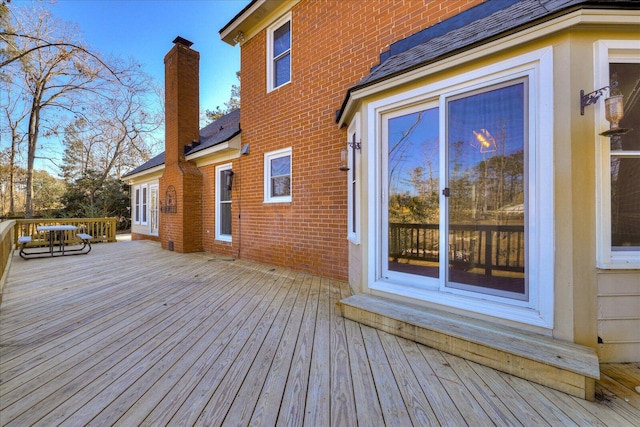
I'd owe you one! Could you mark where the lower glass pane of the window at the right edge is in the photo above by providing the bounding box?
[611,157,640,251]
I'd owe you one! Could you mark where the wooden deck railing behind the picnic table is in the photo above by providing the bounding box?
[13,218,117,246]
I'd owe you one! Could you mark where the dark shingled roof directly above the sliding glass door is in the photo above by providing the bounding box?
[336,0,640,121]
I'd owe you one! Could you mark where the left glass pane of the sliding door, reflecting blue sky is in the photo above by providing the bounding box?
[387,108,440,277]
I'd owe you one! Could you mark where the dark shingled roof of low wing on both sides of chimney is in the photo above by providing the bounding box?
[123,110,240,178]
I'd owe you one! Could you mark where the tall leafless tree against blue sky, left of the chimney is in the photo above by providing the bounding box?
[0,3,157,218]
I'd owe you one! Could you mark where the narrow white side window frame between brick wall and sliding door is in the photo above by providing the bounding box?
[347,113,362,245]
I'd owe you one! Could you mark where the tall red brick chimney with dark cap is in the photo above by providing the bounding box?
[159,37,202,252]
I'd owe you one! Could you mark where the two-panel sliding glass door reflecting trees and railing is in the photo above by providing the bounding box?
[382,79,529,300]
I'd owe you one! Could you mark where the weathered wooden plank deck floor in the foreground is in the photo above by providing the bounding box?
[0,241,640,426]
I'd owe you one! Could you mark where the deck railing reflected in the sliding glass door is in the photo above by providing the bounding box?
[389,223,525,276]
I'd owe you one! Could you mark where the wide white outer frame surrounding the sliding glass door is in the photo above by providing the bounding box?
[366,47,555,329]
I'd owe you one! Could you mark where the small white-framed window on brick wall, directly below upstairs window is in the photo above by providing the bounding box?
[264,147,291,203]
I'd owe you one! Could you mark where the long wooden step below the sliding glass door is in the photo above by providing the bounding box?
[340,294,600,400]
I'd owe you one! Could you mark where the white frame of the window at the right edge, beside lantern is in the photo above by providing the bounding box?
[596,40,640,269]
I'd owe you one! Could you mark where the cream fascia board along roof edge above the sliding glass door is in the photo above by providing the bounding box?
[338,9,640,128]
